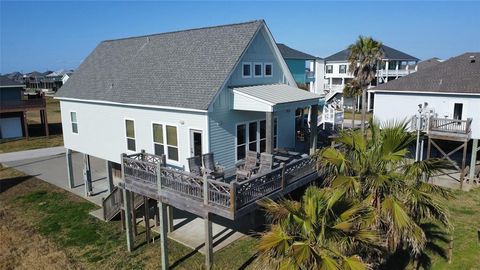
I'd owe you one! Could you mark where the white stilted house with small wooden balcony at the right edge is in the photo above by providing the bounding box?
[370,52,480,188]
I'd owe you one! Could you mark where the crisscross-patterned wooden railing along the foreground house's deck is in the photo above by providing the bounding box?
[122,153,315,215]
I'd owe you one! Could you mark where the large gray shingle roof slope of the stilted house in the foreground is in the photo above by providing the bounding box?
[57,20,264,110]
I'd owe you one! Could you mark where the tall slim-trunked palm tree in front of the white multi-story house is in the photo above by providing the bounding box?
[348,36,383,134]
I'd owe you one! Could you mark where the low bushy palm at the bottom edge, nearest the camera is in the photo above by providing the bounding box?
[257,186,378,270]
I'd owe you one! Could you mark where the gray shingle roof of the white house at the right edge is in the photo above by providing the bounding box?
[372,52,480,93]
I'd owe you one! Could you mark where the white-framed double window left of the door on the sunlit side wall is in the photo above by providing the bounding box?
[152,123,178,161]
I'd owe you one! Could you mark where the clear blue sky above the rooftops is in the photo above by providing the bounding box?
[0,0,480,73]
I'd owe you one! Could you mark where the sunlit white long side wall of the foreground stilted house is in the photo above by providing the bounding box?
[60,100,208,169]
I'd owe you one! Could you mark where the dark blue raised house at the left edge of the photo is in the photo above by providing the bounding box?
[0,76,48,139]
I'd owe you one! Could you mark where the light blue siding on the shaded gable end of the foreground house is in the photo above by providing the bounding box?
[208,30,295,169]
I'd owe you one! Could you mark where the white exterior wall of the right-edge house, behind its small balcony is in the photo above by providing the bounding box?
[373,92,480,139]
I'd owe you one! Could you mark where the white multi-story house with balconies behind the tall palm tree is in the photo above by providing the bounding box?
[323,45,419,110]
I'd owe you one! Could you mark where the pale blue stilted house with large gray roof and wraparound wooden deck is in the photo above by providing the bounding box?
[56,20,320,269]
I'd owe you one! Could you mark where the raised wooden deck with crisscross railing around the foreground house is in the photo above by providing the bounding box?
[122,153,318,220]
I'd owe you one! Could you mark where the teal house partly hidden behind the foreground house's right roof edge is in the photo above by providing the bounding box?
[277,43,324,95]
